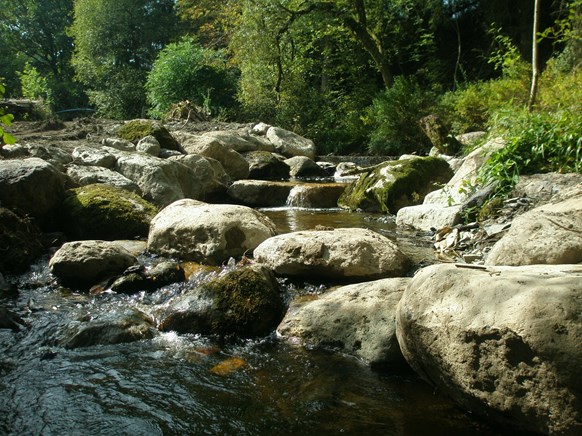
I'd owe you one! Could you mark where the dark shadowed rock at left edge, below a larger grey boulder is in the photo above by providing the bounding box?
[0,208,43,274]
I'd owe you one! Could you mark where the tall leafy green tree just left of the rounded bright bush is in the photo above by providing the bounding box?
[70,0,176,118]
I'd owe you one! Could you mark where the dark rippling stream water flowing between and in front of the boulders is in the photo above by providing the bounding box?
[0,208,508,435]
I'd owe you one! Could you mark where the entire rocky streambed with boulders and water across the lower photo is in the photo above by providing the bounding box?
[0,120,582,434]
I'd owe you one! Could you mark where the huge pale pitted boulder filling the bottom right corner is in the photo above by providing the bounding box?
[396,264,582,435]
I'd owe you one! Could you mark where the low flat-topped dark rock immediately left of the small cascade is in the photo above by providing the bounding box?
[227,180,295,207]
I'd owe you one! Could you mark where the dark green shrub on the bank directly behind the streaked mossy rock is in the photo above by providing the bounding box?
[367,76,436,155]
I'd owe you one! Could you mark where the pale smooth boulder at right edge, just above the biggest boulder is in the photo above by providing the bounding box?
[486,192,582,266]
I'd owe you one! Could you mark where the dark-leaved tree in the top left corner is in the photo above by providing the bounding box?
[0,0,83,107]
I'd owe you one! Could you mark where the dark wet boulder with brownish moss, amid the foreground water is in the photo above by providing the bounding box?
[160,265,285,337]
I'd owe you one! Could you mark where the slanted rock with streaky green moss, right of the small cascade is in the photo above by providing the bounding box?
[338,157,453,214]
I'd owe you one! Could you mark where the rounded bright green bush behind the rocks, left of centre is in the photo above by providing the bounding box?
[146,38,237,118]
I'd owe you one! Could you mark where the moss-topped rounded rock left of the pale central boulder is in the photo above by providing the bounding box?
[63,184,158,240]
